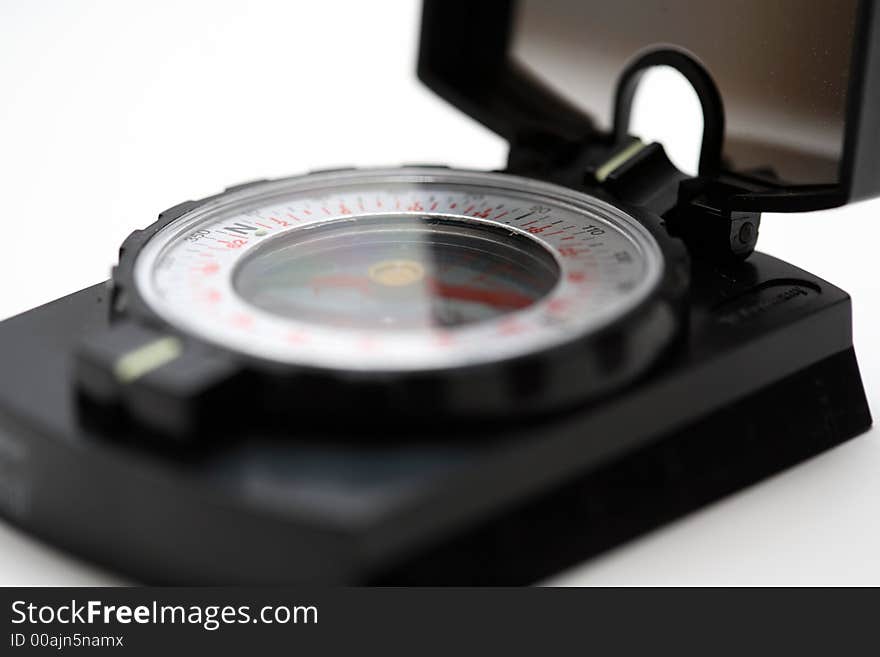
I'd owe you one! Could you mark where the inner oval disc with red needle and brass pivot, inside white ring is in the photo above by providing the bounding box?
[233,214,559,330]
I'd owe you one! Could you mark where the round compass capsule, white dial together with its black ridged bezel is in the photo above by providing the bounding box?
[84,167,685,428]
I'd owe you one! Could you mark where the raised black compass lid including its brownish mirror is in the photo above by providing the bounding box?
[418,0,880,212]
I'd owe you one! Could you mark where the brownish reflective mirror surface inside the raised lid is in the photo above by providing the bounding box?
[513,0,858,184]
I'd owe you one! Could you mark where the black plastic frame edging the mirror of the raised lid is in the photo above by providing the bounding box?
[418,0,880,212]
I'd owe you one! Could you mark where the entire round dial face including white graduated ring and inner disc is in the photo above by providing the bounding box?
[135,168,663,371]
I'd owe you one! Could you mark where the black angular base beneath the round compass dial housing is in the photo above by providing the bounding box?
[0,254,870,584]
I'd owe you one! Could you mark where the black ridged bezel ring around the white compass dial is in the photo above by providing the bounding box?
[112,167,688,416]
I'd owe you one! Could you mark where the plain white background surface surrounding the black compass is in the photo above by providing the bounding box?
[0,0,880,585]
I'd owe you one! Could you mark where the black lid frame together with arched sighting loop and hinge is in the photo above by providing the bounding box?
[418,0,880,258]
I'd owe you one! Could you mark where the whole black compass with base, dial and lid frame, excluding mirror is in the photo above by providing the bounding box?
[0,2,878,583]
